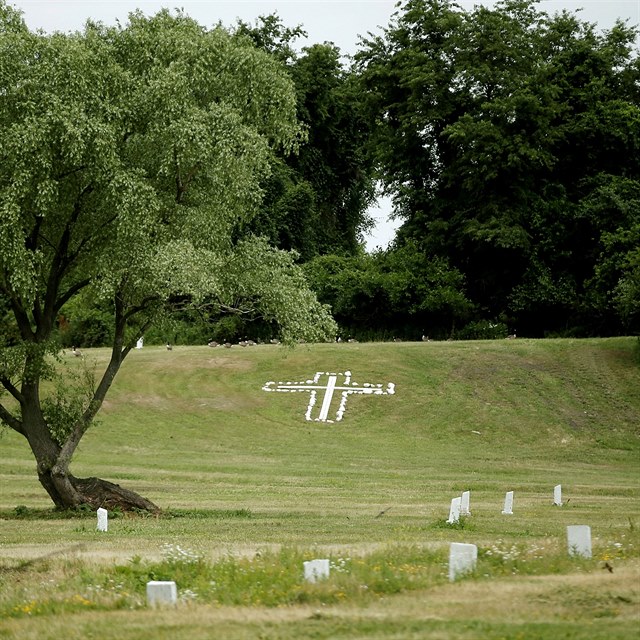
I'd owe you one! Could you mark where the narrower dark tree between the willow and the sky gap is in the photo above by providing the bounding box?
[236,15,374,262]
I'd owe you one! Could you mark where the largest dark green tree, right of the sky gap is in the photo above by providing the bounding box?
[357,0,640,336]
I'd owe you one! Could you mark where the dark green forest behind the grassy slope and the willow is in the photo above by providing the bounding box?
[16,0,640,347]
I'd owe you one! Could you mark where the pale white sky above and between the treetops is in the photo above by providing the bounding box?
[8,0,640,251]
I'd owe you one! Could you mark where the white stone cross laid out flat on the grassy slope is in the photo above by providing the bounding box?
[262,371,395,422]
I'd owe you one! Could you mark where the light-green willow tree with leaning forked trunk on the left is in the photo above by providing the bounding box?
[0,5,334,510]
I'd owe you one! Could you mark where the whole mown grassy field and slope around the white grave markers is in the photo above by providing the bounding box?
[0,338,640,640]
